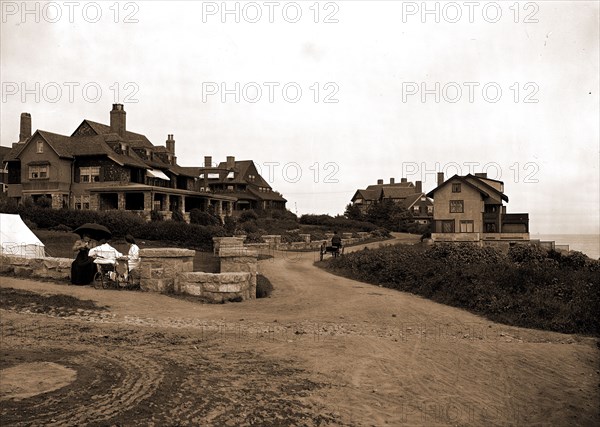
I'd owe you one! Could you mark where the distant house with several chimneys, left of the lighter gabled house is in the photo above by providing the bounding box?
[351,178,433,224]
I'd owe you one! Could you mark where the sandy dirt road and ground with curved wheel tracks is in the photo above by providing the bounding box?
[0,236,600,426]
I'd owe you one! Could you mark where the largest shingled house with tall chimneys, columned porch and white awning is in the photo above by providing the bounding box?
[4,104,264,221]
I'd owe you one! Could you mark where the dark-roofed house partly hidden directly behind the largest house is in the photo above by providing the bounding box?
[182,156,287,211]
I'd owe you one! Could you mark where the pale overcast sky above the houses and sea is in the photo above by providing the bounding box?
[0,1,600,234]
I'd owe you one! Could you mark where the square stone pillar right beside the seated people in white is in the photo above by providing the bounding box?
[140,248,196,293]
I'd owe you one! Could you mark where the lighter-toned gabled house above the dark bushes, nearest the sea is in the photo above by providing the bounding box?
[427,173,529,243]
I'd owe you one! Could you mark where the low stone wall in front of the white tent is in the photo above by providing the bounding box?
[0,254,73,281]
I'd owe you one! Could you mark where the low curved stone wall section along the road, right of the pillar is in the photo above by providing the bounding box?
[175,272,251,303]
